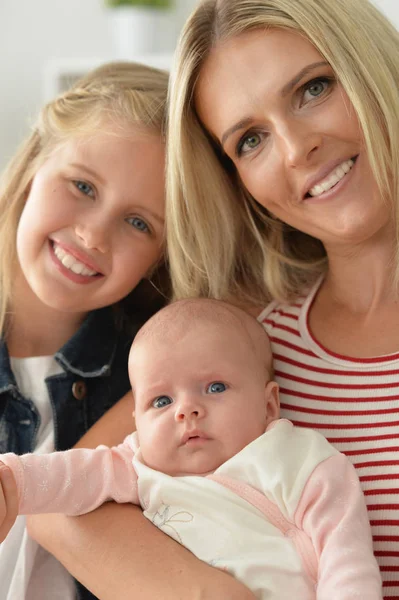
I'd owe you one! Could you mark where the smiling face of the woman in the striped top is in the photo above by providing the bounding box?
[195,29,389,251]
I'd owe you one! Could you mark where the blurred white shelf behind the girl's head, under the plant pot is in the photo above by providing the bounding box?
[43,53,173,102]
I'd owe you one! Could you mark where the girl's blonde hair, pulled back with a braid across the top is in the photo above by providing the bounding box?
[0,62,168,332]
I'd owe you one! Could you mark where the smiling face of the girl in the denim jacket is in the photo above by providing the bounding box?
[17,130,164,315]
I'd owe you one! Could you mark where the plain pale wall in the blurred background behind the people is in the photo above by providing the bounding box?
[0,0,399,169]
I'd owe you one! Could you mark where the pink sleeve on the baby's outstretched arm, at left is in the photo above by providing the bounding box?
[0,436,139,515]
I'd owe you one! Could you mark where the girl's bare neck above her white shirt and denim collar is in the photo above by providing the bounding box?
[6,268,86,358]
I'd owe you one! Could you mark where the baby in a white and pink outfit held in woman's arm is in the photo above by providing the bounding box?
[0,300,382,600]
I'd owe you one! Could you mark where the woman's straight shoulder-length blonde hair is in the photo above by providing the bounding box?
[167,0,399,304]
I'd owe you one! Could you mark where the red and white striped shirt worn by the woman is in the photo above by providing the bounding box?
[258,283,399,600]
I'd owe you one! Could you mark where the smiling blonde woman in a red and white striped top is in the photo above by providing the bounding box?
[27,0,399,598]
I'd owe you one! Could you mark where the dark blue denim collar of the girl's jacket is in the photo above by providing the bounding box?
[0,307,118,393]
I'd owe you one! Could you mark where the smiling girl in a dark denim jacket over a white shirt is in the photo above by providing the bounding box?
[0,63,167,600]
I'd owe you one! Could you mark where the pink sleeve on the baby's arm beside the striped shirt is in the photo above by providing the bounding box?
[295,454,382,600]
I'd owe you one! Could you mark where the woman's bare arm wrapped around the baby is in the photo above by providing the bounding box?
[29,394,254,600]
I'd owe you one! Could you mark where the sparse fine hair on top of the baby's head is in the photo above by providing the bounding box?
[132,298,273,379]
